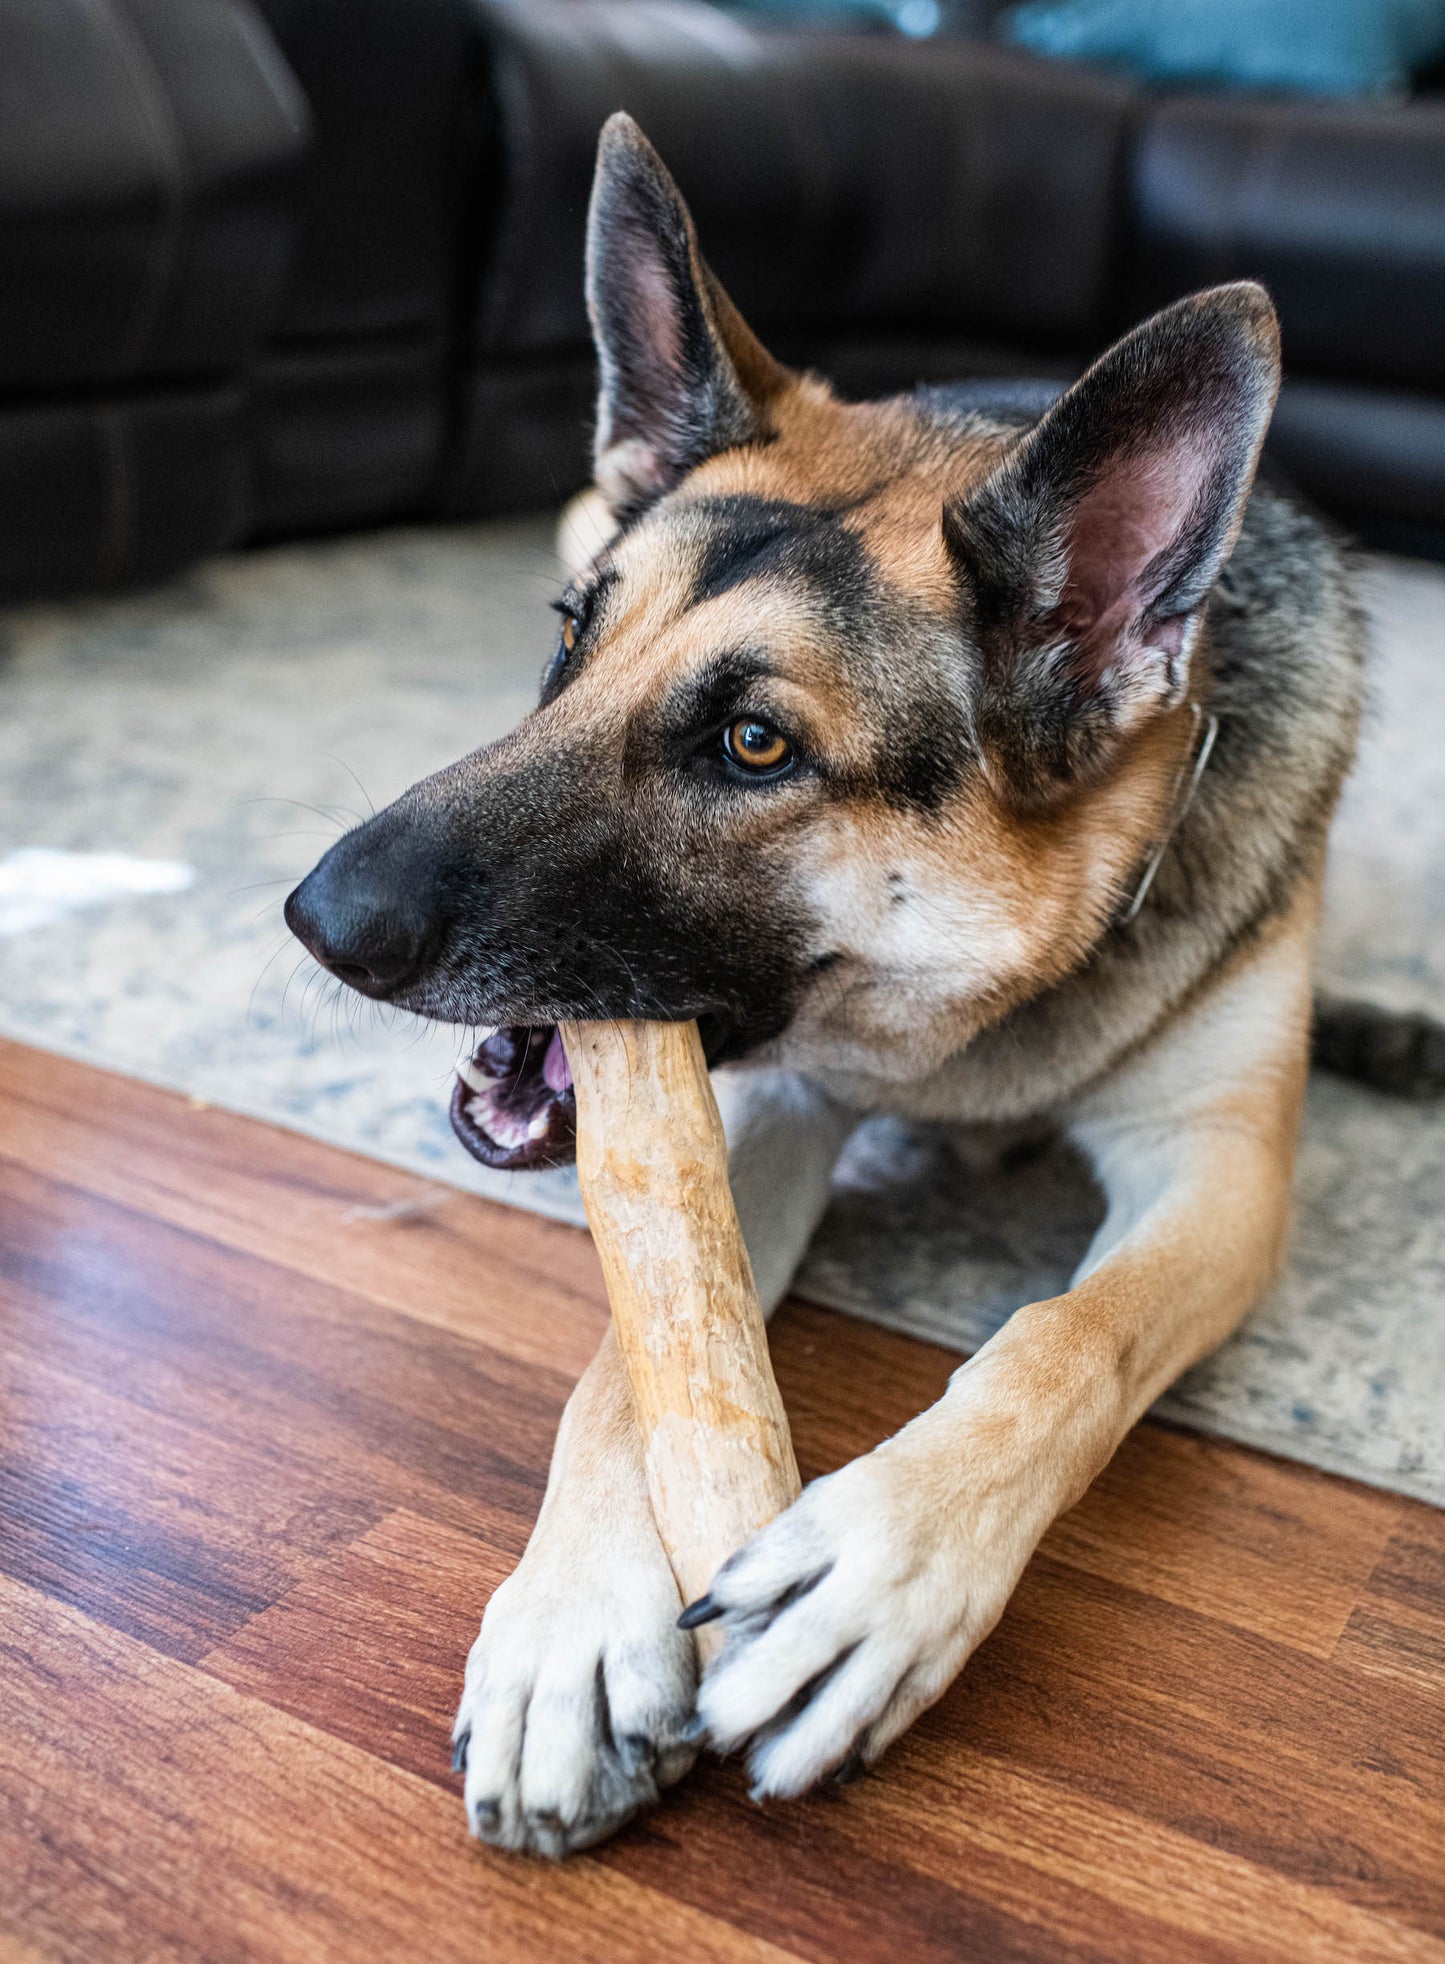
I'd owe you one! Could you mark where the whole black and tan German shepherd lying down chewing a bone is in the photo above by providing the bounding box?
[287,116,1365,1856]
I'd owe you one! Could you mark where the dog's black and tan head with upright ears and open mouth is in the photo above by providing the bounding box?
[287,116,1278,1165]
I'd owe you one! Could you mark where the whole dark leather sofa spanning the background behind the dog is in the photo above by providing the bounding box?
[0,0,1445,599]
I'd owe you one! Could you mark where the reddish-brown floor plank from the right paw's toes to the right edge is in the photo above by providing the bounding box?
[950,1557,1445,1935]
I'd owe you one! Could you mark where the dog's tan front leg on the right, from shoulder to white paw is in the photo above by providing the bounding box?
[695,896,1313,1795]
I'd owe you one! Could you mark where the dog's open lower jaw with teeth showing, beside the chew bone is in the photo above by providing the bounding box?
[452,1023,577,1173]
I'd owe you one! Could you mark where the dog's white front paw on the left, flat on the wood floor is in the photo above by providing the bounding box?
[452,1536,697,1856]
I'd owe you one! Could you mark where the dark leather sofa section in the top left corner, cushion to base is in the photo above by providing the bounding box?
[0,0,308,597]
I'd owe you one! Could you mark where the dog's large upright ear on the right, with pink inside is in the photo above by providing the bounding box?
[942,283,1280,801]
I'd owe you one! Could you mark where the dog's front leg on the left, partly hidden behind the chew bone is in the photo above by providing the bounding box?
[454,1072,854,1856]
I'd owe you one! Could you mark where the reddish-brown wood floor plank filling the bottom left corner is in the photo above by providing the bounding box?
[0,1583,785,1964]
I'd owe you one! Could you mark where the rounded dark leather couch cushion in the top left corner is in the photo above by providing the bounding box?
[0,0,306,393]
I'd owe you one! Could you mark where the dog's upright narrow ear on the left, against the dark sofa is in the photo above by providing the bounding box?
[587,112,789,520]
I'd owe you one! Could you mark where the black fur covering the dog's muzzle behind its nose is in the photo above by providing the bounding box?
[344,722,817,1059]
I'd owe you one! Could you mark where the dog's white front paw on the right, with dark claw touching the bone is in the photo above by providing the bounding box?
[685,1432,1021,1799]
